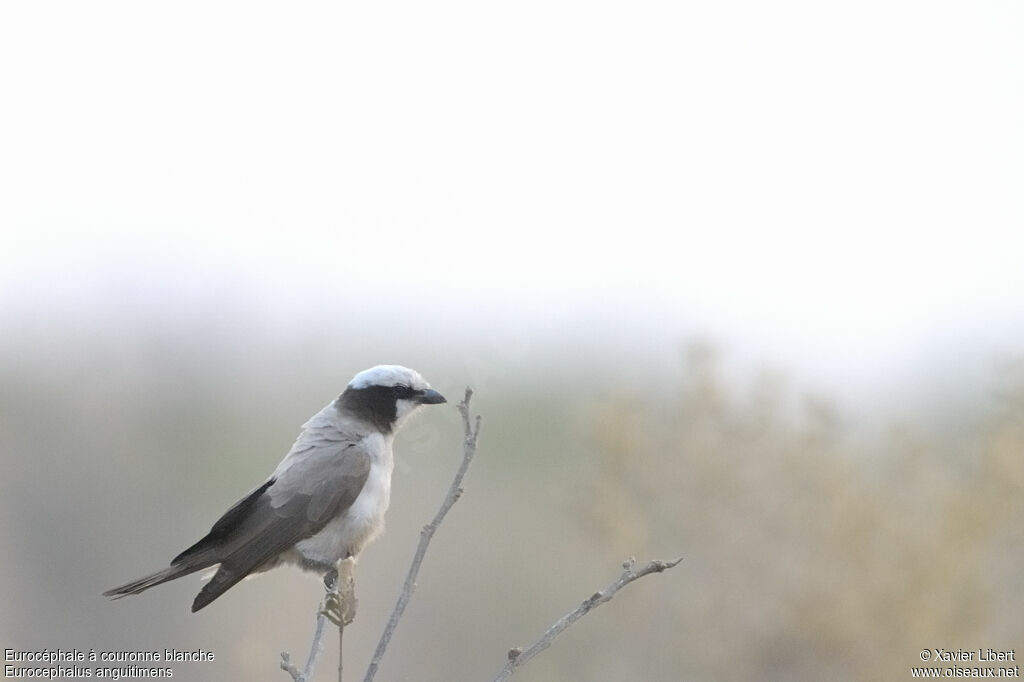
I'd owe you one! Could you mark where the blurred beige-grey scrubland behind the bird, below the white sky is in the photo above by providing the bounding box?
[0,302,1024,681]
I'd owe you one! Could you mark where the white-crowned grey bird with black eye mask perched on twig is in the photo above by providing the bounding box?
[103,365,446,612]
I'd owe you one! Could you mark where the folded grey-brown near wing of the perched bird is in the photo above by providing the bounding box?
[193,440,371,611]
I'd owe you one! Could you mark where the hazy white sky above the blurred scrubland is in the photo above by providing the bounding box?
[0,0,1024,374]
